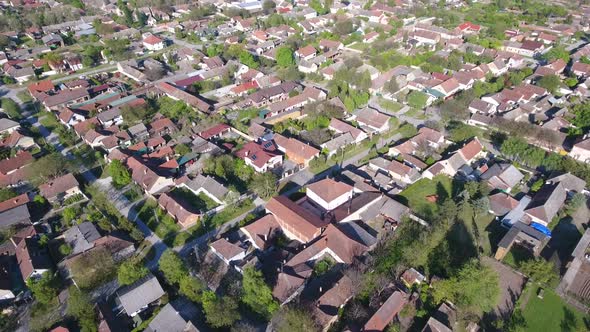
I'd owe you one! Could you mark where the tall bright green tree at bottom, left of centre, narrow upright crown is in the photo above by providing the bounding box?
[242,267,279,318]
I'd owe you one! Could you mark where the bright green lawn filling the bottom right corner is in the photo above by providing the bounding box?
[520,284,588,332]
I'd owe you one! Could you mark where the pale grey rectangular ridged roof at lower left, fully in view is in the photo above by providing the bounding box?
[117,274,165,315]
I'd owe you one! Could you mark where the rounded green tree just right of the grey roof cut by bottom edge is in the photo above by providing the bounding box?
[202,291,240,328]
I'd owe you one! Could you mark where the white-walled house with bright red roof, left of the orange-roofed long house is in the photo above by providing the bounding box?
[236,141,283,173]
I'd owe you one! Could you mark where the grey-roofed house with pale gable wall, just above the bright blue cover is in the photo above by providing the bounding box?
[524,182,567,227]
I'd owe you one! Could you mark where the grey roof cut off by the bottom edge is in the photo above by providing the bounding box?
[145,299,199,332]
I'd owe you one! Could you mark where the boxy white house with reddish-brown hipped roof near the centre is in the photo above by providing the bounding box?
[306,178,354,211]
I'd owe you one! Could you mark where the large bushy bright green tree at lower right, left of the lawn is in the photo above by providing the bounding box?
[433,260,500,312]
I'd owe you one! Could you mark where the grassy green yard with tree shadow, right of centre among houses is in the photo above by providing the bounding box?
[399,176,453,220]
